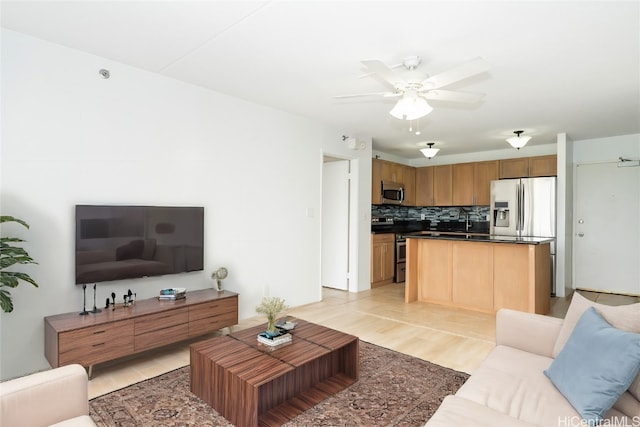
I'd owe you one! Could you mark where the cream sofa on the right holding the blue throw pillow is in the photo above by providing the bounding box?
[426,293,640,427]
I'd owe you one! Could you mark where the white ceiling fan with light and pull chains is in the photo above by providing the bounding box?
[335,56,490,120]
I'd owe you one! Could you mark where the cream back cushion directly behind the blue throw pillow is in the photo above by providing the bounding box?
[553,292,640,360]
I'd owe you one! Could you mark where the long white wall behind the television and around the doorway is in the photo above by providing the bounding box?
[0,30,371,379]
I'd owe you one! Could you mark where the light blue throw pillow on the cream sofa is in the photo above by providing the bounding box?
[544,307,640,425]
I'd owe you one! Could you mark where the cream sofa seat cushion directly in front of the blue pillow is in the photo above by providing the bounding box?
[456,345,581,426]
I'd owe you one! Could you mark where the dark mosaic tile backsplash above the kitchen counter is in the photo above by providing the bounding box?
[371,205,489,225]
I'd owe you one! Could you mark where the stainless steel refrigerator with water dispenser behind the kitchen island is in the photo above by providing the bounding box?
[490,177,556,295]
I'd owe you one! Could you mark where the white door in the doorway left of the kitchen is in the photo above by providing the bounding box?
[321,160,349,291]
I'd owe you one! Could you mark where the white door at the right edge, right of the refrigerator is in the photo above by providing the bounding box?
[573,163,640,295]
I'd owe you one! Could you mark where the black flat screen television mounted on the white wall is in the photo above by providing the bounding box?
[75,205,204,285]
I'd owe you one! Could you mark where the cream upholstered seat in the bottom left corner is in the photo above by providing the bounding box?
[0,365,95,427]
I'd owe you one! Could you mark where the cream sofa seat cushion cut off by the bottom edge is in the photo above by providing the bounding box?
[425,396,535,427]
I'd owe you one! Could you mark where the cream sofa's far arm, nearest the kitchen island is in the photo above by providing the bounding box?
[496,309,563,357]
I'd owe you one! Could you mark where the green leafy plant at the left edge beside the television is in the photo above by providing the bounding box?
[0,215,38,313]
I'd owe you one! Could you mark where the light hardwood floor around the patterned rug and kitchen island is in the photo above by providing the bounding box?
[89,284,639,398]
